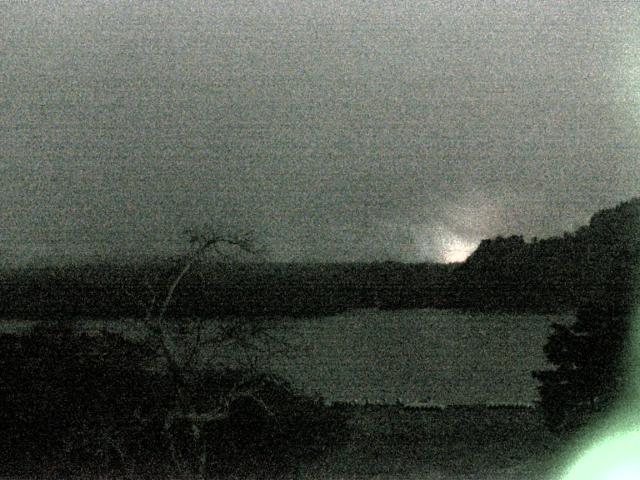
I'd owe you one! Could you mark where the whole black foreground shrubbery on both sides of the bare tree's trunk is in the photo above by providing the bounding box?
[0,325,346,478]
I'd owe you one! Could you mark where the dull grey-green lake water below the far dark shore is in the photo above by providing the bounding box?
[4,309,572,405]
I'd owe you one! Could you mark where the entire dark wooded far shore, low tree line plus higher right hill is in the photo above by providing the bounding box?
[0,198,640,319]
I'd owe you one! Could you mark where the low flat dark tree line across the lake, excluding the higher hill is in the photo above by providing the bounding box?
[0,258,452,319]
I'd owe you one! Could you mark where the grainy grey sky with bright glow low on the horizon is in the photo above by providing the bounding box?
[0,0,640,261]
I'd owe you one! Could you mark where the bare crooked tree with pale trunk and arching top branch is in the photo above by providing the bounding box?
[138,227,290,478]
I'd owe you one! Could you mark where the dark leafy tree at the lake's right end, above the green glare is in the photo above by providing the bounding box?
[533,296,640,434]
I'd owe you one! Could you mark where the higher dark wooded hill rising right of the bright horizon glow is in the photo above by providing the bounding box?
[451,197,640,310]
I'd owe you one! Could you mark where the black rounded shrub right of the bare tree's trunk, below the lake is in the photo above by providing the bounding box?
[164,370,347,479]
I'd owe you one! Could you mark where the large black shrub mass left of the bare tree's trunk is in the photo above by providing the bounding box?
[0,323,168,470]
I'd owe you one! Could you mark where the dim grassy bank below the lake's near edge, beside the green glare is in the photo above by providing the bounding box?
[300,406,560,480]
